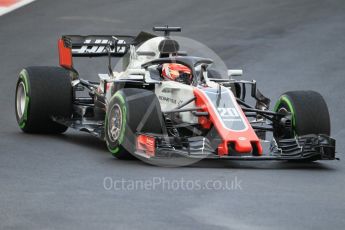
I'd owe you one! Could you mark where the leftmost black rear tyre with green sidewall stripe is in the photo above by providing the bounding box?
[15,66,72,134]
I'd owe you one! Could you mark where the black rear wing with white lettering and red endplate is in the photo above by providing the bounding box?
[58,32,156,69]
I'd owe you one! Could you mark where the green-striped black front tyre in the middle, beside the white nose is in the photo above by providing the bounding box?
[104,88,163,159]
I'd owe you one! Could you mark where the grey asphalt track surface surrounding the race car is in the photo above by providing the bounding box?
[0,0,345,229]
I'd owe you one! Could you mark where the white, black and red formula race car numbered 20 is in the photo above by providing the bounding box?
[15,26,335,161]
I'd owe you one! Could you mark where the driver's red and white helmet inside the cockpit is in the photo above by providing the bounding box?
[161,63,192,84]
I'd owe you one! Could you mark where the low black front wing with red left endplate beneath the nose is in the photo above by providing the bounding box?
[135,134,337,161]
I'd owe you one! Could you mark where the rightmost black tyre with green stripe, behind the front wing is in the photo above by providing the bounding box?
[275,91,331,136]
